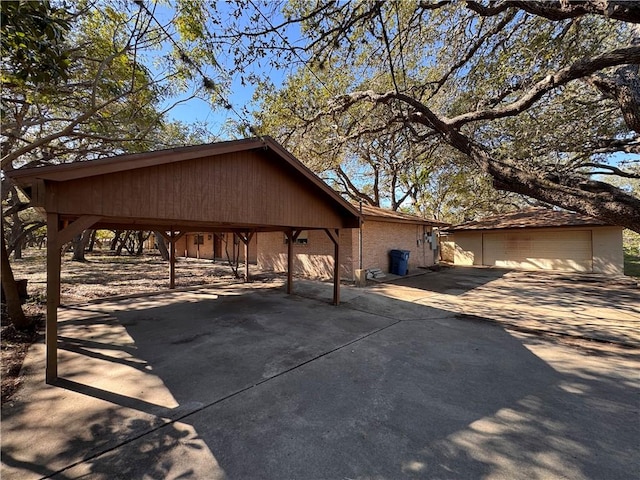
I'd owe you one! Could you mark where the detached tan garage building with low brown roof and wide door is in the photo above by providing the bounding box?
[442,209,624,275]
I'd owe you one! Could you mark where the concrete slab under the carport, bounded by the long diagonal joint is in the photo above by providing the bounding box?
[3,284,391,478]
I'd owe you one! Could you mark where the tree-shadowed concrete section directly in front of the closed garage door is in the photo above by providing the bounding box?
[388,267,640,348]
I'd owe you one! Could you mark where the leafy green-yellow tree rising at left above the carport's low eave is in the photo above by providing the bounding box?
[0,1,225,323]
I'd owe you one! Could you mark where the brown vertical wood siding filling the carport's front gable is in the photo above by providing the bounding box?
[45,150,351,228]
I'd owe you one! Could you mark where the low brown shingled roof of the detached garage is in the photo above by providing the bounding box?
[447,208,609,232]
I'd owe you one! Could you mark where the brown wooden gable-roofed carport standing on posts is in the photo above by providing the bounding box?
[8,137,360,383]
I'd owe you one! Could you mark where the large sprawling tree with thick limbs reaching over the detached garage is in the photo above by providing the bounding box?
[216,0,640,231]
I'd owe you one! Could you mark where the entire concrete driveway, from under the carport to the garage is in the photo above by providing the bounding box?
[0,269,640,480]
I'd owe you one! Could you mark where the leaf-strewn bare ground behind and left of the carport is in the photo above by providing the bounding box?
[0,249,268,403]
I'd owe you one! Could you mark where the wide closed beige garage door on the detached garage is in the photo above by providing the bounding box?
[482,230,593,272]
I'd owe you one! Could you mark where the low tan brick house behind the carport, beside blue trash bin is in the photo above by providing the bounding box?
[257,205,448,280]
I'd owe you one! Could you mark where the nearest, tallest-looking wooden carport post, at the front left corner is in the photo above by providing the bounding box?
[45,213,62,384]
